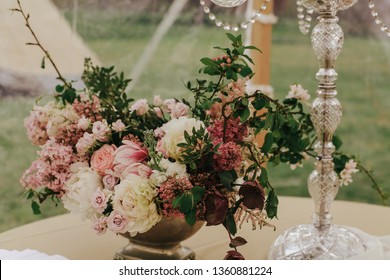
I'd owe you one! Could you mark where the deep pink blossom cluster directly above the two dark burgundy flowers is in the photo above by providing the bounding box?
[214,142,242,171]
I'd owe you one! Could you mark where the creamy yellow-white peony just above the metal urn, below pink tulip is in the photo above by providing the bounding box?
[113,174,161,236]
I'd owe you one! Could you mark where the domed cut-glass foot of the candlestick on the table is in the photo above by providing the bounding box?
[268,224,367,260]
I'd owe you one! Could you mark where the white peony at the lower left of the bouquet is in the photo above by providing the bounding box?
[61,167,103,219]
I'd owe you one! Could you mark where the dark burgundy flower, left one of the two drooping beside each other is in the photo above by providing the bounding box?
[205,193,229,226]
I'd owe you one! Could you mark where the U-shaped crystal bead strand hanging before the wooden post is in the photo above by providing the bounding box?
[199,0,271,31]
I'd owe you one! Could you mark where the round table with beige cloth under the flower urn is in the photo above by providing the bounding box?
[0,197,390,260]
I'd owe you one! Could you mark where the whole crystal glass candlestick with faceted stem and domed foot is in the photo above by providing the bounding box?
[268,0,366,259]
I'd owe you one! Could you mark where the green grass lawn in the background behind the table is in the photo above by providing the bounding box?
[0,11,390,232]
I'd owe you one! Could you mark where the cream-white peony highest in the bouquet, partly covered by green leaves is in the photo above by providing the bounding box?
[159,116,205,160]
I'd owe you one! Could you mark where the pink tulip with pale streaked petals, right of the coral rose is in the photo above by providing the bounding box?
[114,140,148,167]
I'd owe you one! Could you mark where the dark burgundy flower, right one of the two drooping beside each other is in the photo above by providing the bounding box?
[238,181,265,210]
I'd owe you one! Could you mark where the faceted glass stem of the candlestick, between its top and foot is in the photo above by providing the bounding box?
[308,10,344,229]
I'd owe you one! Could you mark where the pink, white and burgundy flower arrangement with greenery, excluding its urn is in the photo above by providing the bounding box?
[15,1,386,259]
